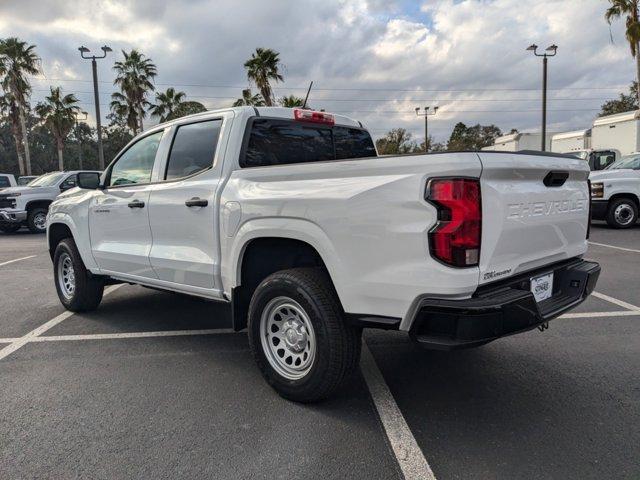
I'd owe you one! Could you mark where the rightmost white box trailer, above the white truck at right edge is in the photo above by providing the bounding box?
[591,110,640,155]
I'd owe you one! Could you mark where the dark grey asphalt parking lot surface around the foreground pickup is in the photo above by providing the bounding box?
[0,225,640,479]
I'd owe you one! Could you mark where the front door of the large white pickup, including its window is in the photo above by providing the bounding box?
[89,131,163,278]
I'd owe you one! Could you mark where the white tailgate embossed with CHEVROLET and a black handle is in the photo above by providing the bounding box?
[479,152,589,284]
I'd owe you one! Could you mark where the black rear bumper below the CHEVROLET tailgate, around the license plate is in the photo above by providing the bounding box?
[409,260,600,350]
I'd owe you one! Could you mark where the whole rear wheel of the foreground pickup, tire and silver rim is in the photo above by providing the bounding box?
[248,268,361,402]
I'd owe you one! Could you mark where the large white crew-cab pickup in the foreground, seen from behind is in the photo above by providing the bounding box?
[48,107,600,402]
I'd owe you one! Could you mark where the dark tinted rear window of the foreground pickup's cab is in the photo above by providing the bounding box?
[240,119,376,167]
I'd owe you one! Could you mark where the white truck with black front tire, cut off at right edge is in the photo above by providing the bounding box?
[589,153,640,228]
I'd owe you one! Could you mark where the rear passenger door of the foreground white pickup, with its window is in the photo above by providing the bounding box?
[149,113,232,289]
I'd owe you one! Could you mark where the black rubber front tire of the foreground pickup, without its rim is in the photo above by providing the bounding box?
[53,238,104,312]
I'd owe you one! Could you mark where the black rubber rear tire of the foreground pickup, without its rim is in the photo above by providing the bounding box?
[248,268,362,403]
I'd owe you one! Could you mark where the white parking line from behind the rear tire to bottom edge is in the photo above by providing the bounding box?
[360,341,436,480]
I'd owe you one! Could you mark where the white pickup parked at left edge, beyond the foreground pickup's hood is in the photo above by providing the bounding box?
[0,171,97,233]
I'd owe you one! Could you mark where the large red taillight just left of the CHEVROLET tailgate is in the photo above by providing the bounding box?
[426,178,482,267]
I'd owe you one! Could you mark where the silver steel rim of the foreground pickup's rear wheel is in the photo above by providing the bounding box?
[260,297,317,380]
